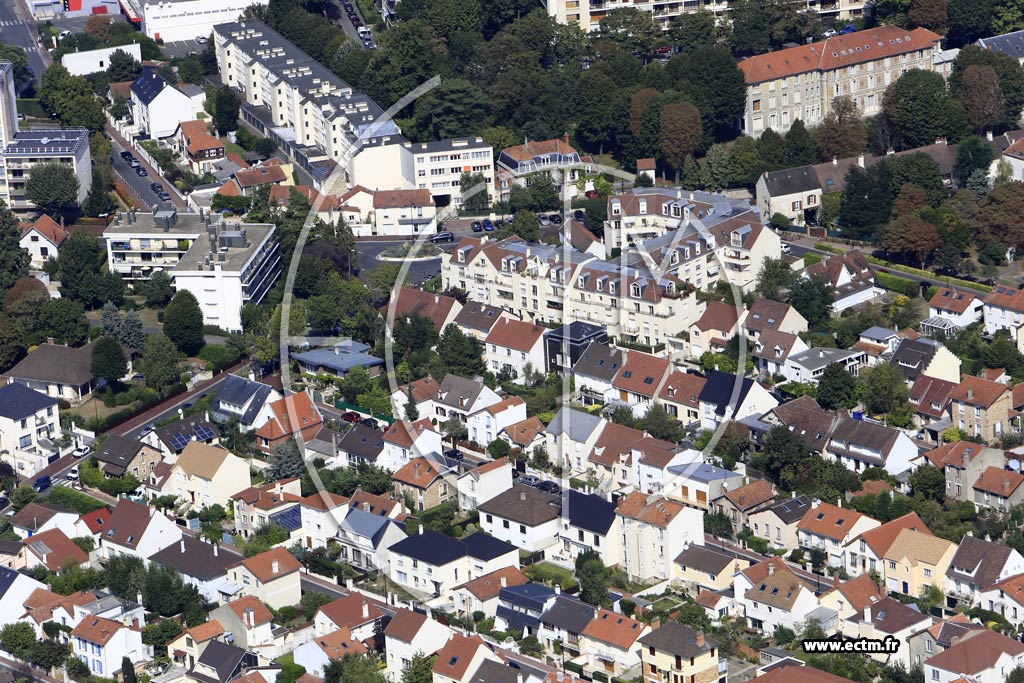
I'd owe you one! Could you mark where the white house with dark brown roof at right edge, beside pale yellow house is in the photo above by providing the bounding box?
[945,531,1024,616]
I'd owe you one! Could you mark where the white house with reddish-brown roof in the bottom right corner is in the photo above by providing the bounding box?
[925,629,1024,683]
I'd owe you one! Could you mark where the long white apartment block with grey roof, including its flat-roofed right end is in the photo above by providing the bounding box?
[213,20,495,207]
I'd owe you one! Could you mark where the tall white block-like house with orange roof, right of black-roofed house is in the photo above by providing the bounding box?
[615,492,703,581]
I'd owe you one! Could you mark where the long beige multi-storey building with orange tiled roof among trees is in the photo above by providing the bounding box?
[739,26,941,137]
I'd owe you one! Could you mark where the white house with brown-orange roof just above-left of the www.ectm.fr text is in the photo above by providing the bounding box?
[732,558,825,633]
